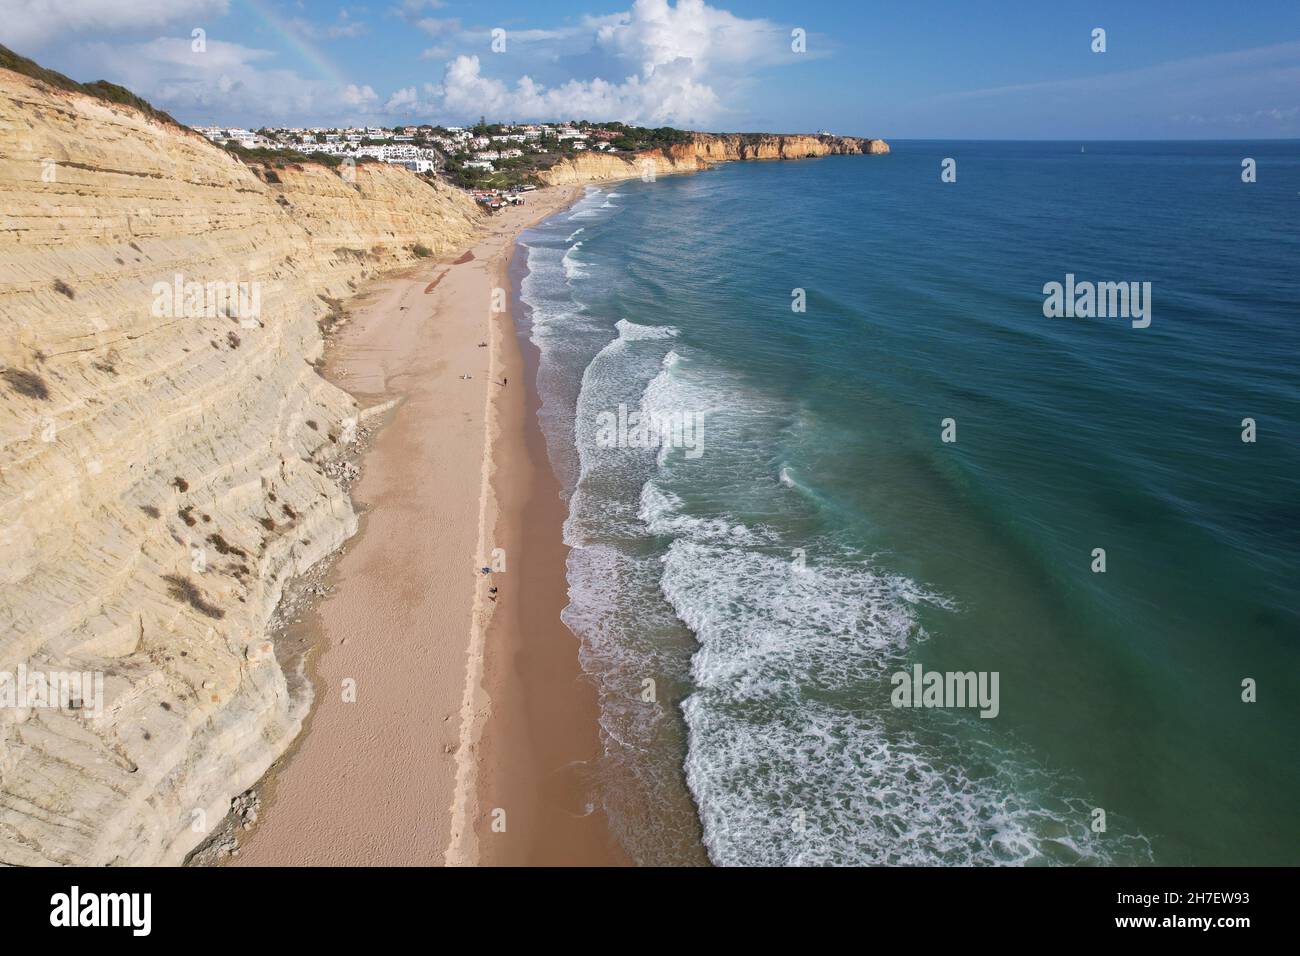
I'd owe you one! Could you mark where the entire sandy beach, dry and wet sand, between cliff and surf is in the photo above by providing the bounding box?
[233,187,620,865]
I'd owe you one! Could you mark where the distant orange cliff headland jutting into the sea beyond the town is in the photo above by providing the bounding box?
[541,133,889,186]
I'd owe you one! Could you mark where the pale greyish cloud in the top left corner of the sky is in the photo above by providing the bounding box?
[0,0,229,52]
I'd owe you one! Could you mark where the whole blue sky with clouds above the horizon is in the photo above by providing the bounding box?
[0,0,1300,139]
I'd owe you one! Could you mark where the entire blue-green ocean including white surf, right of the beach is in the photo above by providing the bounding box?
[517,142,1300,865]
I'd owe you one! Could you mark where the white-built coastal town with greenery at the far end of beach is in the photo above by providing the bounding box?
[194,120,689,208]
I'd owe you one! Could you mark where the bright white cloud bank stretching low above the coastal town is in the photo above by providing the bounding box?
[22,0,801,127]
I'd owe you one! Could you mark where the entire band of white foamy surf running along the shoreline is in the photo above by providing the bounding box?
[524,171,1143,864]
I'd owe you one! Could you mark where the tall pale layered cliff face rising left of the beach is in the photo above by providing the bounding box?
[0,70,481,865]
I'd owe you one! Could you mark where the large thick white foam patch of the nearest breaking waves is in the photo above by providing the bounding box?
[662,538,1147,865]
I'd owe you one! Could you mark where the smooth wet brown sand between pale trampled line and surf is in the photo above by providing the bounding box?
[475,217,631,866]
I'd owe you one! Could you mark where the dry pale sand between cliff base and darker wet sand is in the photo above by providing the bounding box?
[231,187,597,865]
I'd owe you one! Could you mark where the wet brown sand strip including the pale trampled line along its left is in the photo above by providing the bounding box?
[446,187,625,865]
